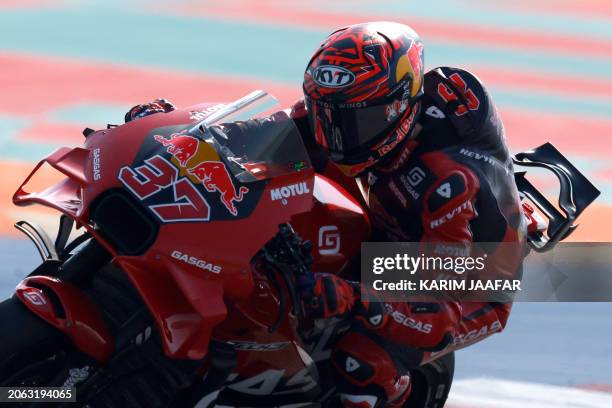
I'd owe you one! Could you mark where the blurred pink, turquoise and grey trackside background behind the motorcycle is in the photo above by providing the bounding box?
[0,0,612,407]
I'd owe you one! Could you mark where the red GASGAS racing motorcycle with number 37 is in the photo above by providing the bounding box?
[0,91,597,408]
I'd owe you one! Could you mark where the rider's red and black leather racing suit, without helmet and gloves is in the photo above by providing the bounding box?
[292,67,523,407]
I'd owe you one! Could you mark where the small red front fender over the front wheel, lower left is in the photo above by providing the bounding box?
[15,276,115,362]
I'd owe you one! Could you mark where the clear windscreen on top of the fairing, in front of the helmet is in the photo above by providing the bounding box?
[198,91,311,183]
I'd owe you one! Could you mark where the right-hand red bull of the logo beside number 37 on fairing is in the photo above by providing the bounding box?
[187,161,249,216]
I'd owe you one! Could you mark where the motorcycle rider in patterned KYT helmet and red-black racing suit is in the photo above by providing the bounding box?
[126,22,523,408]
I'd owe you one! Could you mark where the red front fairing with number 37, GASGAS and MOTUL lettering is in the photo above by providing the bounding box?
[13,91,314,359]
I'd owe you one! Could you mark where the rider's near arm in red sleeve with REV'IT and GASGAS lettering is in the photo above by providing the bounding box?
[379,152,511,360]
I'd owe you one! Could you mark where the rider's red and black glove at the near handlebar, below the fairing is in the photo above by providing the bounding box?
[301,273,356,319]
